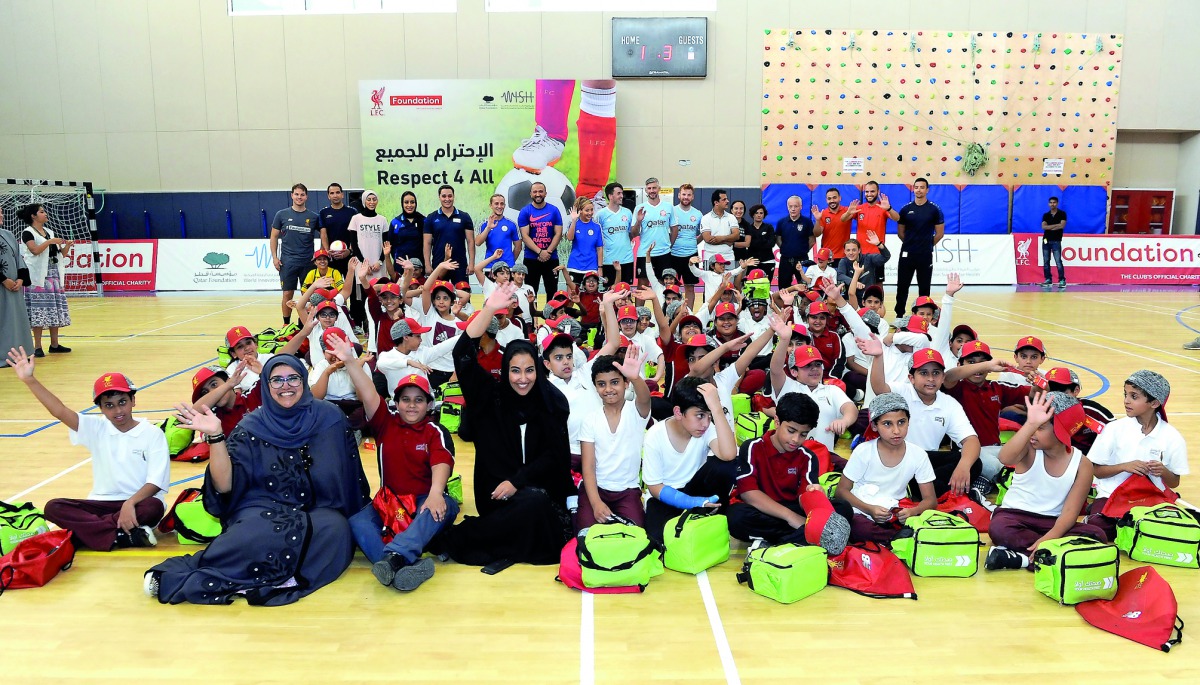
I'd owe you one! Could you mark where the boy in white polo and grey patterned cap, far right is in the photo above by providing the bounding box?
[1086,369,1190,540]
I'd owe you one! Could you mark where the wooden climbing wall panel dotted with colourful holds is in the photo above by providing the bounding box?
[762,29,1123,186]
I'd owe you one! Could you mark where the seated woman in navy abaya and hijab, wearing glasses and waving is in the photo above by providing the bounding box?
[145,354,368,606]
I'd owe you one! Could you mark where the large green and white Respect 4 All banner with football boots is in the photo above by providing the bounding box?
[359,79,617,227]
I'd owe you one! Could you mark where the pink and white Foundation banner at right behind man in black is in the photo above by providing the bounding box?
[1013,233,1200,286]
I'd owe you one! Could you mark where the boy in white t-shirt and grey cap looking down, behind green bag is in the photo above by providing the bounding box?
[836,392,937,542]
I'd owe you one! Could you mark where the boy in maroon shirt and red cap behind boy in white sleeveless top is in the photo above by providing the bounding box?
[942,341,1032,504]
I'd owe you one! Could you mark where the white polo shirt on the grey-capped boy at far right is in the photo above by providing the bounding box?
[1087,416,1190,498]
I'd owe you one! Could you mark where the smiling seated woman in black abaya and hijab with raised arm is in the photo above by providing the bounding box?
[444,283,572,566]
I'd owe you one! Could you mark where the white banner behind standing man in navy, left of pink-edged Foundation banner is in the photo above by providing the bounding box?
[883,234,1016,288]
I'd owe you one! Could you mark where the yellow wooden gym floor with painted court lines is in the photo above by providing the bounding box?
[0,287,1200,685]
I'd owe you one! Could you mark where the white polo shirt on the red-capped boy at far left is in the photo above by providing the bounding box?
[67,412,171,504]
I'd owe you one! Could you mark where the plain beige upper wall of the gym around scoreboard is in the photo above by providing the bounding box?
[0,0,1200,232]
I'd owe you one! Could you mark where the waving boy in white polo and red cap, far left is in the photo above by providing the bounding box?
[8,348,170,552]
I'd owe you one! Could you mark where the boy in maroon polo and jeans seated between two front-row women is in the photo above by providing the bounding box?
[331,340,458,591]
